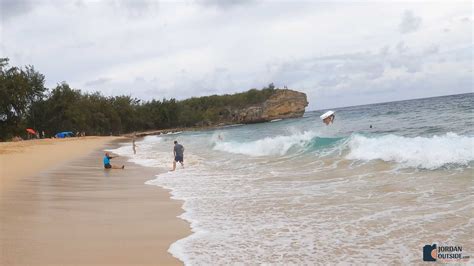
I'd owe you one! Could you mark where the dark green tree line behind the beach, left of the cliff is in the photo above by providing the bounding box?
[0,58,275,140]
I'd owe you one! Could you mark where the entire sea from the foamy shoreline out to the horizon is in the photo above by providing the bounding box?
[109,93,474,265]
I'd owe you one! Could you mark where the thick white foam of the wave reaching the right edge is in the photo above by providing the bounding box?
[346,133,474,169]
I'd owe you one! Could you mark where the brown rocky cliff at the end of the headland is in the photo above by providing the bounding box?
[229,89,308,124]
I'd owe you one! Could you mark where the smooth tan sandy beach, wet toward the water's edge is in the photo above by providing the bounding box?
[0,137,190,265]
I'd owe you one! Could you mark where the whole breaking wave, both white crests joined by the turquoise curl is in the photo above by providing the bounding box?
[214,131,474,169]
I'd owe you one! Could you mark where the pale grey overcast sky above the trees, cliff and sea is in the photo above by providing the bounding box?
[0,0,474,110]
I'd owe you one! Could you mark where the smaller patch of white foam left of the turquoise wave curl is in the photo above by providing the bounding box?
[214,131,316,156]
